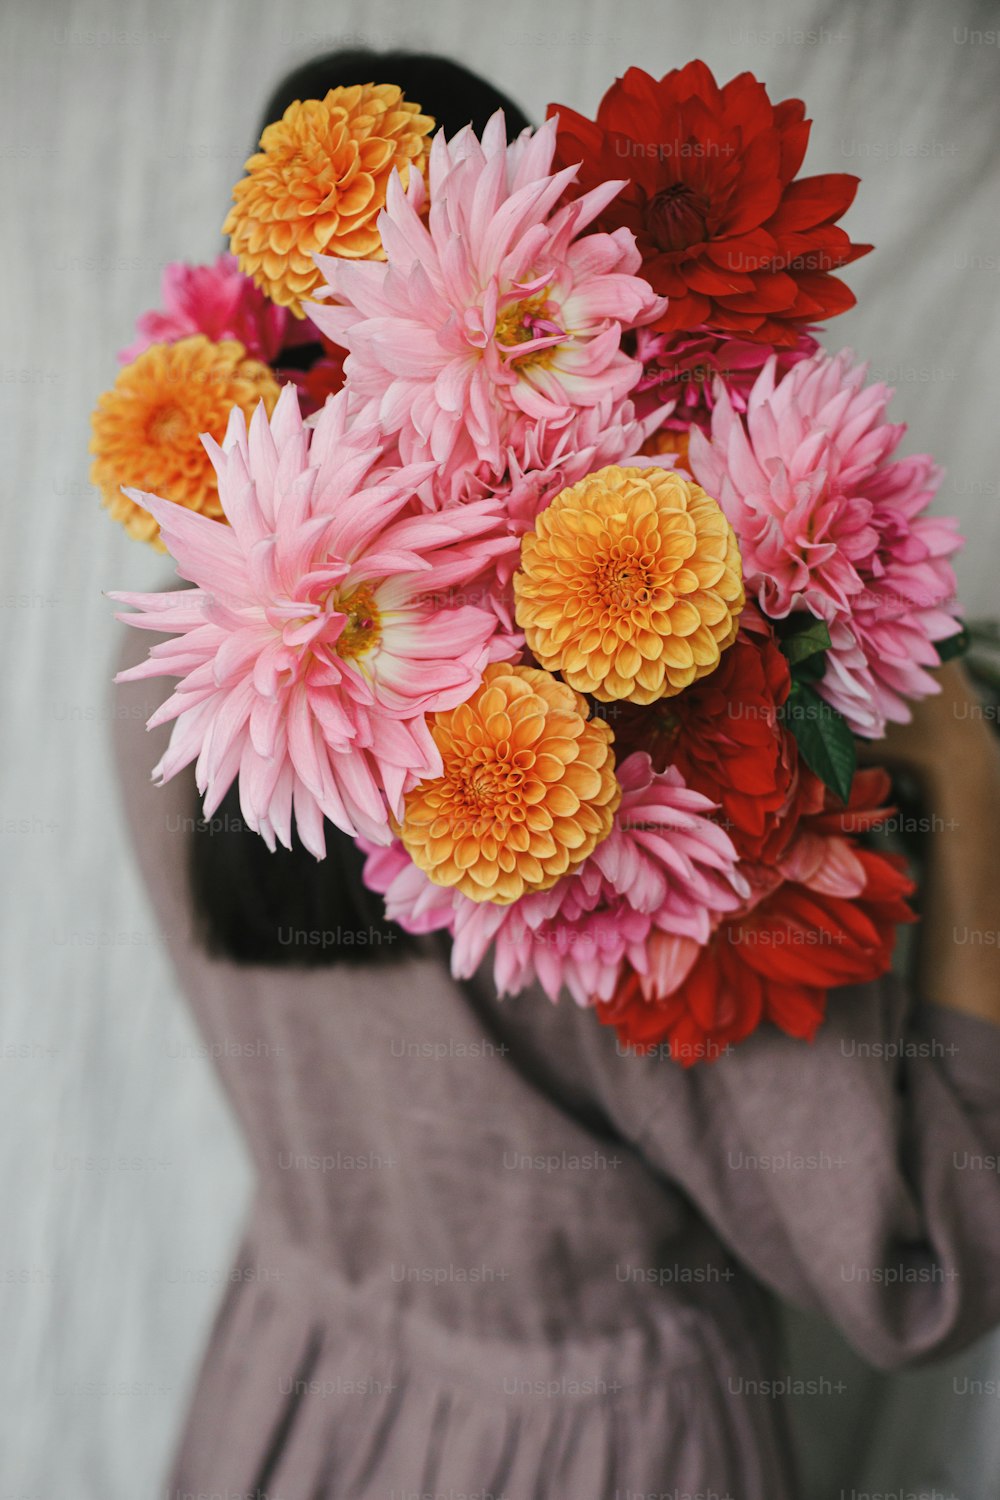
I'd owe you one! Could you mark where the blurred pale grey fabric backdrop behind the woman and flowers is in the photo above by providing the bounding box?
[0,0,1000,1500]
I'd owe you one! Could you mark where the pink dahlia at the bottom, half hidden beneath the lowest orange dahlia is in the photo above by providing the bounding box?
[364,753,747,1005]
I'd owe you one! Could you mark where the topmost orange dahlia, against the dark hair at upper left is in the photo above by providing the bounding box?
[222,84,435,318]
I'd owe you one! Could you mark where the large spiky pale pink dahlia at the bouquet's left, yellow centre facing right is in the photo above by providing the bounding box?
[111,386,510,858]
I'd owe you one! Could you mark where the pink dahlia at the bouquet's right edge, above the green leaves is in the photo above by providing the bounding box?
[690,353,961,738]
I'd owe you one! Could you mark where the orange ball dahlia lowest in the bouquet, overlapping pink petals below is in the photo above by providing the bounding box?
[399,662,622,906]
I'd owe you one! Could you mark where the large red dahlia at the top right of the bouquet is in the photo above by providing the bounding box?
[549,62,871,347]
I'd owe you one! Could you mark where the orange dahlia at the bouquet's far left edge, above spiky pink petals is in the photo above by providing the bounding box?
[90,333,279,552]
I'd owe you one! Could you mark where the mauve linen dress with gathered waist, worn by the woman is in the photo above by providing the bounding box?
[115,632,1000,1500]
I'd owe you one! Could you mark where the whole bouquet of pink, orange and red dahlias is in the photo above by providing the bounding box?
[91,62,961,1064]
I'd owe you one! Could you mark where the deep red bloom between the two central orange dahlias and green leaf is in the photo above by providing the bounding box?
[615,621,801,861]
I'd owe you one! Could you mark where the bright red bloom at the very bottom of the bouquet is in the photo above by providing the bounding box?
[595,771,915,1067]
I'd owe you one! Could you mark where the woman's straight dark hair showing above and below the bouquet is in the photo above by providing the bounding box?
[187,51,529,968]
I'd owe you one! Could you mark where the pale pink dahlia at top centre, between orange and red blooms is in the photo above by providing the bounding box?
[309,111,663,500]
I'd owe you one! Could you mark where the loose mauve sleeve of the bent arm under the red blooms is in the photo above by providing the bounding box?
[590,978,1000,1370]
